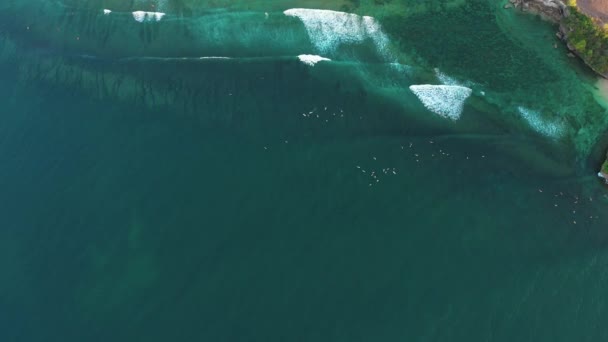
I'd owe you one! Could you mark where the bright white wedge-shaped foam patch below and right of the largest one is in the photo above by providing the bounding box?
[410,84,473,120]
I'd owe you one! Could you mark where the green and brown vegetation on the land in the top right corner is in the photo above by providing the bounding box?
[564,4,608,74]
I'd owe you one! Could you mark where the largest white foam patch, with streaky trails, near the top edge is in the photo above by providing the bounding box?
[283,8,388,57]
